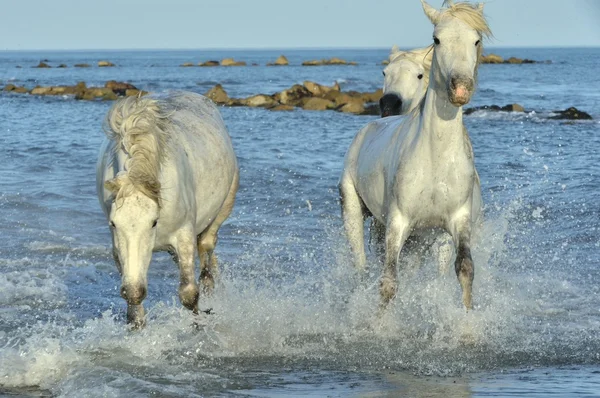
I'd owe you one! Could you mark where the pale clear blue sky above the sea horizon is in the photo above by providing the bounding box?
[0,0,600,50]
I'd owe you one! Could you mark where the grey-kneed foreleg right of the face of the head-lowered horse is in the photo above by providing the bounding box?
[173,232,199,314]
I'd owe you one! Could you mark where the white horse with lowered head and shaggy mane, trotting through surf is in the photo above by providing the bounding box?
[96,92,239,327]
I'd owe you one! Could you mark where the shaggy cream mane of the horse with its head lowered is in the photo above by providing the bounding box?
[104,97,168,203]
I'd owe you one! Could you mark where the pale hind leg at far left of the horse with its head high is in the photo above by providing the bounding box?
[339,181,367,270]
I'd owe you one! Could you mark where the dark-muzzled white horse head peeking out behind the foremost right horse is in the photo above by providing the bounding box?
[379,46,433,117]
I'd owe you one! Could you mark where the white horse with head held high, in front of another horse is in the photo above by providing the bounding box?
[340,0,491,310]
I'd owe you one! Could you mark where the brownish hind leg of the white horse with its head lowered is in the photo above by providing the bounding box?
[197,171,239,295]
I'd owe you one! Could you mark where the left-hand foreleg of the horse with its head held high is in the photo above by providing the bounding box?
[380,215,410,309]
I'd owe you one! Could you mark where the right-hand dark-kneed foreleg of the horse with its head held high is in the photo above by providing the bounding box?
[452,215,475,311]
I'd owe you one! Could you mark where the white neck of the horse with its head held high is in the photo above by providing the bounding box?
[421,68,464,148]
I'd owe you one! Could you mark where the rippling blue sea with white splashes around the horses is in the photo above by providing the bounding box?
[0,48,600,397]
